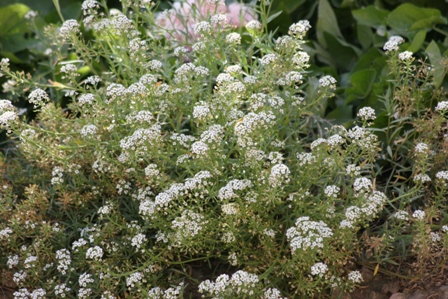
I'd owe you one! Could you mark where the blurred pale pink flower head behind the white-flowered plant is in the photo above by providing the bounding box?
[156,0,257,42]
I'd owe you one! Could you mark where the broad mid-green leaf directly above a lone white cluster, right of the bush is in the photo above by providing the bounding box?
[345,69,376,104]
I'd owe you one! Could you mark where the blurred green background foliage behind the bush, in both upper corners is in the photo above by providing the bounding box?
[0,0,448,148]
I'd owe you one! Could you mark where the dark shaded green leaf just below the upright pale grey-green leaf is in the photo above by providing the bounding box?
[324,32,360,71]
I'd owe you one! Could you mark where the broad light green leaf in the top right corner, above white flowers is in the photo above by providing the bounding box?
[387,3,447,37]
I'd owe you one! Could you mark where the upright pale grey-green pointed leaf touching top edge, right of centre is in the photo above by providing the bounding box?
[316,0,343,47]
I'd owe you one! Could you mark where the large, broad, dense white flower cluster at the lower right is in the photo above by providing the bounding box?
[286,216,333,254]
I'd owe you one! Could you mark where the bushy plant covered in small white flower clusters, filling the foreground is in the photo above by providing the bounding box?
[0,0,448,298]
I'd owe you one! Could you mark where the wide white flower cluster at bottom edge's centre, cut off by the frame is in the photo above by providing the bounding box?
[199,270,259,298]
